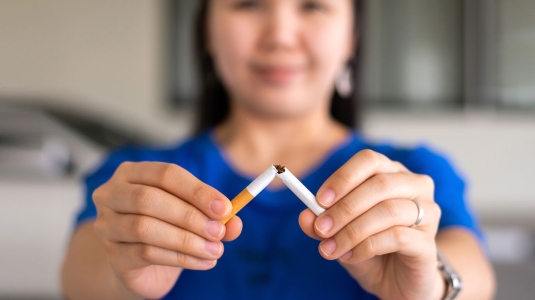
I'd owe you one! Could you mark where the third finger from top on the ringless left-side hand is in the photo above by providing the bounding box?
[100,214,223,260]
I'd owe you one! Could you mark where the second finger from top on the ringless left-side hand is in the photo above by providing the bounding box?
[108,184,225,241]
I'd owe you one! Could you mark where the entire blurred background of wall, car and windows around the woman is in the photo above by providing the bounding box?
[0,0,535,299]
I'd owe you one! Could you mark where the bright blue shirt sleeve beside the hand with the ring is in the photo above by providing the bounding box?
[406,147,483,241]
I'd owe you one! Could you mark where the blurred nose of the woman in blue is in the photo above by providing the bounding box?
[261,1,299,51]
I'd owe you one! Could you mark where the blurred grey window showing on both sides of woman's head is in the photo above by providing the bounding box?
[169,0,535,111]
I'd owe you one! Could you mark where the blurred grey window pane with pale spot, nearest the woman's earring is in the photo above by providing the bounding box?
[362,0,463,105]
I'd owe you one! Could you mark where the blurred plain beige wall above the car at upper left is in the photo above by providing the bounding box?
[0,0,188,142]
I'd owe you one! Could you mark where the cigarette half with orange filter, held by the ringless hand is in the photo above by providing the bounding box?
[221,165,277,224]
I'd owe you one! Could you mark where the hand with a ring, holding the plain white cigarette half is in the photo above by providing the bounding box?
[299,150,444,300]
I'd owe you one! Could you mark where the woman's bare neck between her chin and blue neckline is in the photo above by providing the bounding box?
[216,105,348,175]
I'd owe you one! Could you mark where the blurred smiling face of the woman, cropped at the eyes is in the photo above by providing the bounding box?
[207,0,355,118]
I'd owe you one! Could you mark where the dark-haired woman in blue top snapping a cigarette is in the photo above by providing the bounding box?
[62,0,494,300]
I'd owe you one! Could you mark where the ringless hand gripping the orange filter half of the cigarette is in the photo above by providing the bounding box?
[93,162,242,299]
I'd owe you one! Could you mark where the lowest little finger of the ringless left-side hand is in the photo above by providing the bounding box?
[108,243,217,270]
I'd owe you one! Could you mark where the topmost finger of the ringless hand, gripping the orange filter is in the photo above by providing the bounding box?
[119,162,232,220]
